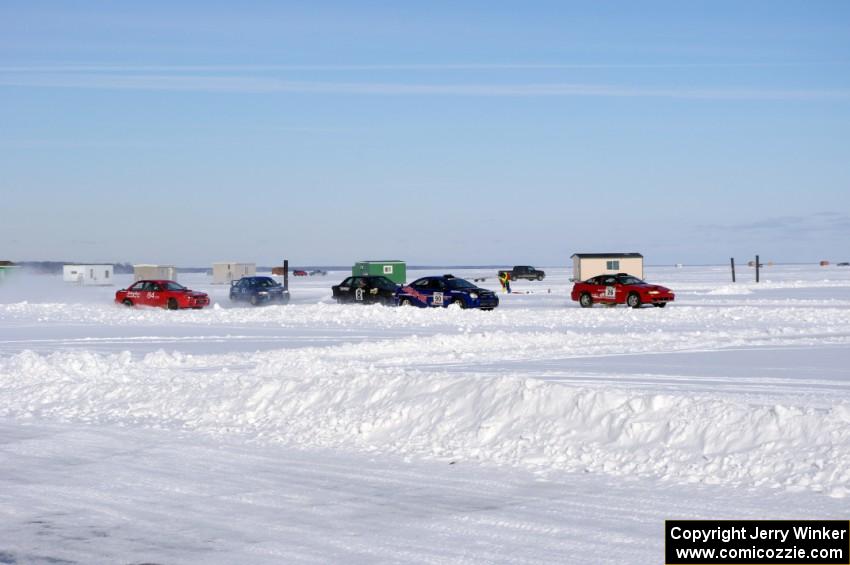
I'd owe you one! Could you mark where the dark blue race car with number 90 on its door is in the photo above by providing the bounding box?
[398,275,499,310]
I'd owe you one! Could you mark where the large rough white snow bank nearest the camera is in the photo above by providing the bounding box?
[0,346,850,497]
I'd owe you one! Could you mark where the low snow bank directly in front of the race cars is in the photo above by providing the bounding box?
[0,298,850,333]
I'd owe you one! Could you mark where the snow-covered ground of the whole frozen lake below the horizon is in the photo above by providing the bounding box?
[0,265,850,563]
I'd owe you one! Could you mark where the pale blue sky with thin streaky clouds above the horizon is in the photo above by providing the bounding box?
[0,1,850,266]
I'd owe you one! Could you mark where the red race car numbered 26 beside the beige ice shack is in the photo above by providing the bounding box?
[570,273,676,308]
